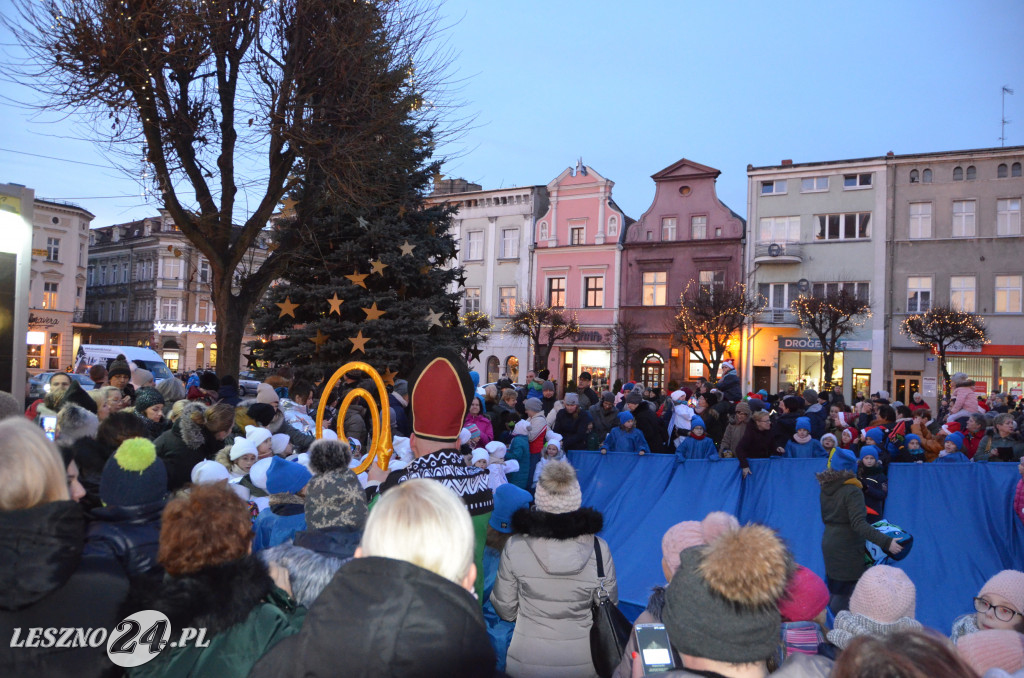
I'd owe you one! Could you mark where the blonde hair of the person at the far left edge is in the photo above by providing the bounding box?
[0,418,70,511]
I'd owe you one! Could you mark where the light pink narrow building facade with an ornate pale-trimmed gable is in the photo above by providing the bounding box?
[532,162,633,391]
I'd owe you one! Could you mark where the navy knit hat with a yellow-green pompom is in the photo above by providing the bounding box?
[99,438,167,506]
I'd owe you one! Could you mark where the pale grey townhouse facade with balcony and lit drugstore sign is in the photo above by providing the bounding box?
[741,157,888,401]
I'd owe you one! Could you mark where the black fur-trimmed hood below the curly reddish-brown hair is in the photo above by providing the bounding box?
[125,555,274,638]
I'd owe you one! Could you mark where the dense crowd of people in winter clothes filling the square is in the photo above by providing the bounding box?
[0,351,1024,678]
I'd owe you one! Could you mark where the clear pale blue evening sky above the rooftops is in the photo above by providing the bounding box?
[0,0,1024,226]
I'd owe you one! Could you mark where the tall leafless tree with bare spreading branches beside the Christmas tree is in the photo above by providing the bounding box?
[3,0,457,374]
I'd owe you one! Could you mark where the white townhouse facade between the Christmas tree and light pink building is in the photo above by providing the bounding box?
[427,178,548,383]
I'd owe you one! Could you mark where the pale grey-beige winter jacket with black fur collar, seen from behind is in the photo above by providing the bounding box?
[490,508,618,678]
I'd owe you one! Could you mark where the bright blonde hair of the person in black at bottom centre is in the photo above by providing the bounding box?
[361,478,473,585]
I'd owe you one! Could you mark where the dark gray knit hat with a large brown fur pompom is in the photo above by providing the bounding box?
[662,524,794,664]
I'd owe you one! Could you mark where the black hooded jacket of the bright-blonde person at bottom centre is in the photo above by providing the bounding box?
[250,557,495,678]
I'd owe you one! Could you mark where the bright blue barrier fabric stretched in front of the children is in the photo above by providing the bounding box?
[568,452,1024,635]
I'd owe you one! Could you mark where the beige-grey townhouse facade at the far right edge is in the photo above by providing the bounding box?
[885,146,1024,406]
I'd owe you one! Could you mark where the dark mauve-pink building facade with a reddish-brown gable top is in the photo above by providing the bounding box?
[618,158,745,388]
